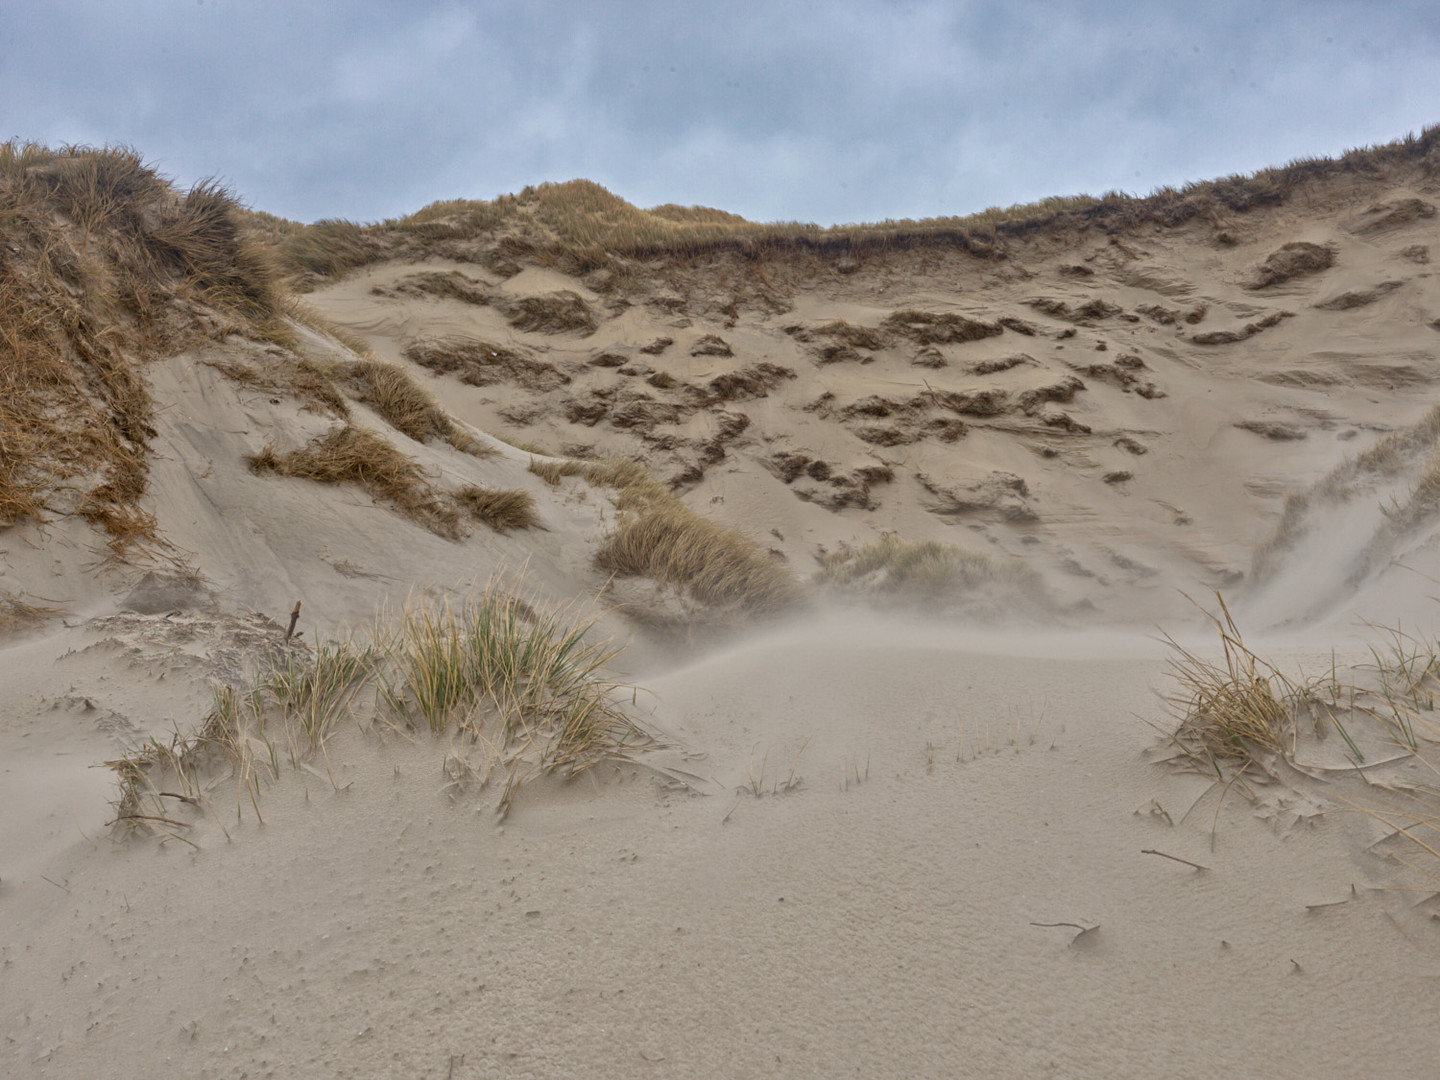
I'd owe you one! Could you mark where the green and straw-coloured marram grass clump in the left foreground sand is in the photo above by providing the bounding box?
[107,580,649,842]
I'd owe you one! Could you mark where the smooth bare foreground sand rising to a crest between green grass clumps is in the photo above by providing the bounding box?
[0,625,1440,1077]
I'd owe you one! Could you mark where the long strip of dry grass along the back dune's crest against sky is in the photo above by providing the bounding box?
[262,127,1440,292]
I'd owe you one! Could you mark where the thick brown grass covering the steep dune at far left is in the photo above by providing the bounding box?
[0,141,288,557]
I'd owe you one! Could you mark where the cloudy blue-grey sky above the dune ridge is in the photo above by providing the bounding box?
[0,0,1440,225]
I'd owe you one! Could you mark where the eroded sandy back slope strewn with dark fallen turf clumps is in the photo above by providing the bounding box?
[310,186,1440,619]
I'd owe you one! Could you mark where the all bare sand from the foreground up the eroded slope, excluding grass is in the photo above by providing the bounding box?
[0,148,1440,1080]
